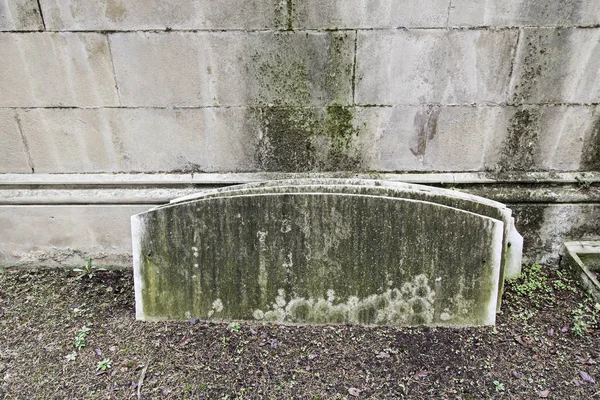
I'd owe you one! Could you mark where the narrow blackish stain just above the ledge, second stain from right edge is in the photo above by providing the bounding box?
[498,107,540,171]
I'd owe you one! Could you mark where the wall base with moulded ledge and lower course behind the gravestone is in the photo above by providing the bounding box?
[0,172,600,267]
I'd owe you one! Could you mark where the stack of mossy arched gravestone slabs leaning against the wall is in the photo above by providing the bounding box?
[132,179,521,326]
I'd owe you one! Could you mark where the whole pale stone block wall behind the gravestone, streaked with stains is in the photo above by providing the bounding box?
[0,0,600,264]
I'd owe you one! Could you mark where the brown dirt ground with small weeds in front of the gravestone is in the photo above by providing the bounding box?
[0,267,600,400]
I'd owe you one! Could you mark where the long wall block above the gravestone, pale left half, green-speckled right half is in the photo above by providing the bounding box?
[110,32,354,106]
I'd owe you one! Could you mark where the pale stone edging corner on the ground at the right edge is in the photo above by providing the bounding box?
[560,240,600,303]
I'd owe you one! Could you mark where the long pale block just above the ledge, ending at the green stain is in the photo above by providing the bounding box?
[19,108,254,173]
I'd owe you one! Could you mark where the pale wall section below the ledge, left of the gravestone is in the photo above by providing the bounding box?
[0,205,149,267]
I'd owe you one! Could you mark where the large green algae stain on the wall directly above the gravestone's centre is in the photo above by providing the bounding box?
[250,33,361,172]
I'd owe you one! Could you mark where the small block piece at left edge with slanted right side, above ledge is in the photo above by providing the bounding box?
[0,110,32,174]
